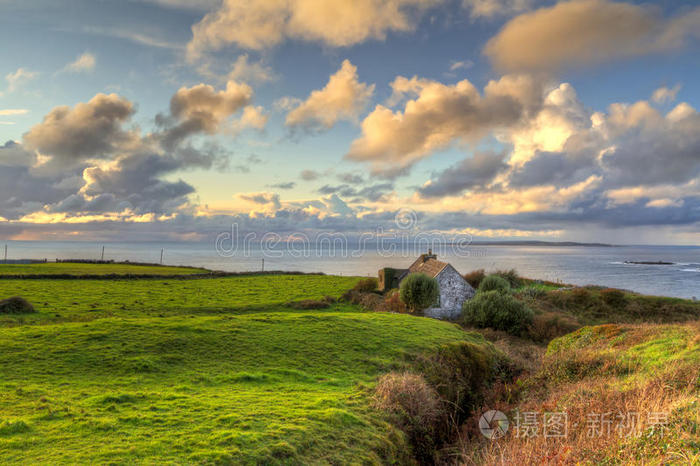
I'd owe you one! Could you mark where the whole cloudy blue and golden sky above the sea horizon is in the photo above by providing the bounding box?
[0,0,700,245]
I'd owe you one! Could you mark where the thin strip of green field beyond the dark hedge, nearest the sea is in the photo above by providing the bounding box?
[0,262,208,275]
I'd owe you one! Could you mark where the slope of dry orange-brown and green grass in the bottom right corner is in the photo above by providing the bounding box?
[450,323,700,465]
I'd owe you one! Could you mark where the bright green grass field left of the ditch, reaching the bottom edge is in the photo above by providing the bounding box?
[0,275,487,464]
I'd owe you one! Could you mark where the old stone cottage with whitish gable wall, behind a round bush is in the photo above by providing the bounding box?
[379,250,475,319]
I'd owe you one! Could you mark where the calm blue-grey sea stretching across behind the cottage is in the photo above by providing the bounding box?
[0,241,700,298]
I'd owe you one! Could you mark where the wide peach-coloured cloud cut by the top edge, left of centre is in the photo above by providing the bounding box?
[187,0,441,59]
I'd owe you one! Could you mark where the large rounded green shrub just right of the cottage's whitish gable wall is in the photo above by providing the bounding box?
[462,292,533,335]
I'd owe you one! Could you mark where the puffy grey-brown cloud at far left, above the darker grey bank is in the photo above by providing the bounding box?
[24,94,137,165]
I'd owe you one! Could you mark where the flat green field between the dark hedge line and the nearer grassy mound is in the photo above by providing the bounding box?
[0,275,358,325]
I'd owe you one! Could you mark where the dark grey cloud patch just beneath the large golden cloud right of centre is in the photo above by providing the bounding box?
[418,152,508,197]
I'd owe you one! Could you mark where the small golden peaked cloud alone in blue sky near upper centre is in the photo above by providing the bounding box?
[285,60,374,130]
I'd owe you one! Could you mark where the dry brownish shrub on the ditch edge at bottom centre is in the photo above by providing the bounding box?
[374,372,444,464]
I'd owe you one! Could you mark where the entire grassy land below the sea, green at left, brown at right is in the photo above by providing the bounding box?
[0,264,700,465]
